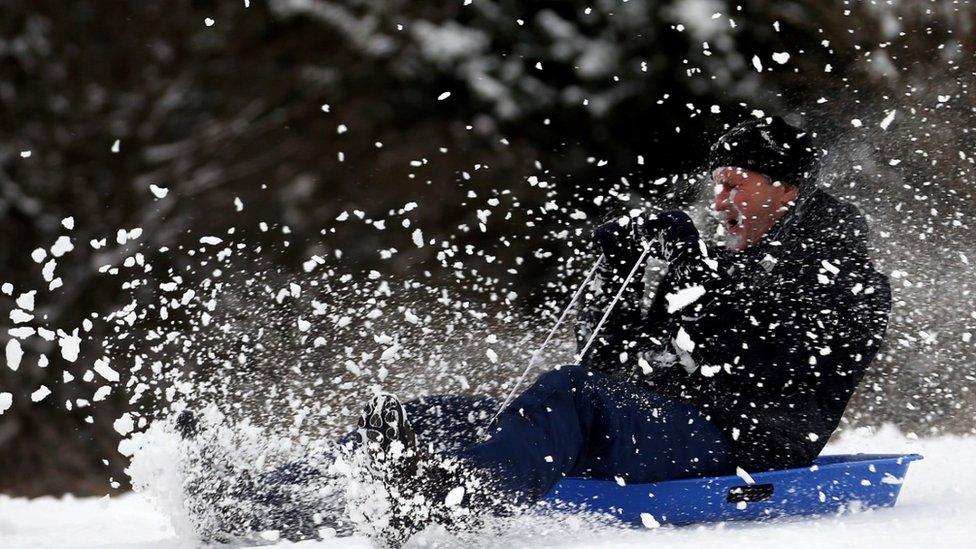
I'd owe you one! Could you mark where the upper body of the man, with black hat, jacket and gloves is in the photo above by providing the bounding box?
[584,114,890,470]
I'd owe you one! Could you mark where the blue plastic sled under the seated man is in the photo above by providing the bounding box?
[547,454,922,526]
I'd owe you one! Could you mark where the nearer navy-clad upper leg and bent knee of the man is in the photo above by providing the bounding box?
[457,366,732,503]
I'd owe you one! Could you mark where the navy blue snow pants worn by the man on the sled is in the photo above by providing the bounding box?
[252,366,735,532]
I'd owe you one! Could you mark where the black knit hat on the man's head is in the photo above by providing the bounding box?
[708,116,817,187]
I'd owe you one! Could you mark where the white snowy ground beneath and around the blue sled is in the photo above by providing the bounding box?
[0,429,976,549]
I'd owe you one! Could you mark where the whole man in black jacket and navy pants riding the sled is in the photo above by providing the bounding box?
[181,117,890,543]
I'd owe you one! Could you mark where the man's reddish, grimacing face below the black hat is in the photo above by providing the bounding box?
[712,167,799,251]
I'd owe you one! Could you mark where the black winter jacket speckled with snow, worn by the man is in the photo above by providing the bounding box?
[577,190,891,471]
